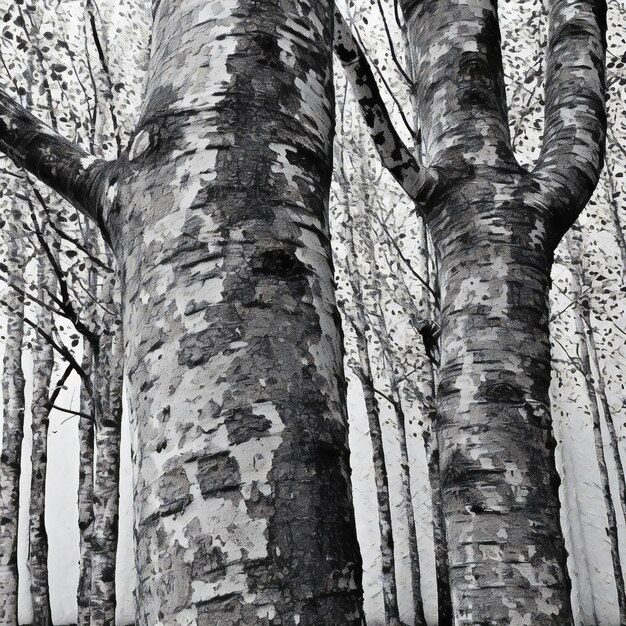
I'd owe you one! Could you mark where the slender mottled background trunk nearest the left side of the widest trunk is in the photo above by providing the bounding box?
[91,278,123,626]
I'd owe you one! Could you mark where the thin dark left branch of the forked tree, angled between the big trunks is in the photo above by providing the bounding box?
[334,9,437,209]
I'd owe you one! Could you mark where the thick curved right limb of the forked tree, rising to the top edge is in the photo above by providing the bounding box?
[533,0,606,239]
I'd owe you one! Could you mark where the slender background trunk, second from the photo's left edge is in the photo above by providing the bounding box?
[29,259,54,626]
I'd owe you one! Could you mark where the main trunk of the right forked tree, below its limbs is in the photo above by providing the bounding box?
[431,176,571,626]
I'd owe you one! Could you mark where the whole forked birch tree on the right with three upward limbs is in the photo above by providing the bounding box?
[335,0,606,625]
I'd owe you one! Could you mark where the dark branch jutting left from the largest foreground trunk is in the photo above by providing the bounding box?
[0,89,116,228]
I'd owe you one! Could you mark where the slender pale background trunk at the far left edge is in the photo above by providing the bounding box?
[0,226,25,626]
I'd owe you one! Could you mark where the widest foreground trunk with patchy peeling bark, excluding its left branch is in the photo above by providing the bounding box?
[102,0,363,626]
